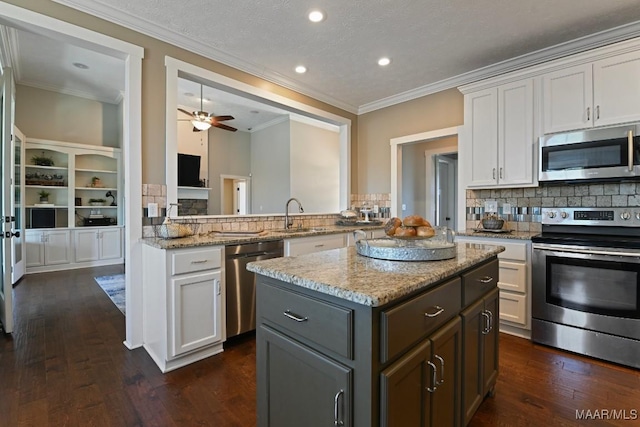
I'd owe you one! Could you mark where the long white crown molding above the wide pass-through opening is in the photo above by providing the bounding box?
[53,0,358,114]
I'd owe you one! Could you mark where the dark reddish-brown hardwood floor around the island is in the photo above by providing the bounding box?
[0,267,640,427]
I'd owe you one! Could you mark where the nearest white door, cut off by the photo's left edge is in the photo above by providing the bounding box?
[0,67,15,333]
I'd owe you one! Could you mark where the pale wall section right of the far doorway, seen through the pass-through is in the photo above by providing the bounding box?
[251,120,291,214]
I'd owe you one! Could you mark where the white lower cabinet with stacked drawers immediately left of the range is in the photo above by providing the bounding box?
[456,236,531,337]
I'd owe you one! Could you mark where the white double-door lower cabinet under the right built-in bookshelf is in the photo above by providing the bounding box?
[73,227,122,262]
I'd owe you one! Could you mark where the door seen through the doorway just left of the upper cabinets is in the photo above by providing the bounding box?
[435,155,458,230]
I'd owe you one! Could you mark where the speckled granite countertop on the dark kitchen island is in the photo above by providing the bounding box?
[247,244,504,307]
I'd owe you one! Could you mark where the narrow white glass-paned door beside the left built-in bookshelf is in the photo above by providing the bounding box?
[11,126,26,283]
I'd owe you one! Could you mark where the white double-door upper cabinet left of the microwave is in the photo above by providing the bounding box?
[461,79,537,188]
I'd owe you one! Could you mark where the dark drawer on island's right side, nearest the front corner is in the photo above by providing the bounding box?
[380,278,462,363]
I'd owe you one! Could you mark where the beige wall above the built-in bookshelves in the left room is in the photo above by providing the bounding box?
[15,85,122,148]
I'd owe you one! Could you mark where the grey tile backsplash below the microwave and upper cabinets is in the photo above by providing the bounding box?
[466,182,640,232]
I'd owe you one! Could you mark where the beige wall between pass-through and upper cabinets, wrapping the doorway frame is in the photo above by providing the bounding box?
[360,89,464,194]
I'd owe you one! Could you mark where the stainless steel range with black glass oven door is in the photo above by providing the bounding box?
[531,207,640,368]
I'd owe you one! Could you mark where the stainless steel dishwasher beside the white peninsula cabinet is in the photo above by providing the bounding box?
[224,240,284,338]
